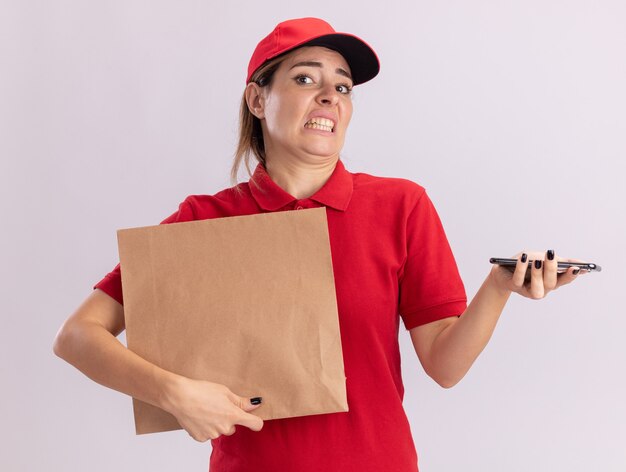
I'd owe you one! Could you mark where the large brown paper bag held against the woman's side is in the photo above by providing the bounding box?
[118,208,348,434]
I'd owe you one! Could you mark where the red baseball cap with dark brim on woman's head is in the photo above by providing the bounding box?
[246,18,380,85]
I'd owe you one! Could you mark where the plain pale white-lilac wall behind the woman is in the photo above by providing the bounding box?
[0,0,626,472]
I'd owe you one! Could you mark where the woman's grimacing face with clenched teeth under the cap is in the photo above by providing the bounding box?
[248,47,352,162]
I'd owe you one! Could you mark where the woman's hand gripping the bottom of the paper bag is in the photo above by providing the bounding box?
[166,377,263,442]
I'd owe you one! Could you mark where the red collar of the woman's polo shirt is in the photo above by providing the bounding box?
[249,159,353,211]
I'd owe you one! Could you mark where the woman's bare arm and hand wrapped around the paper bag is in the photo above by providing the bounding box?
[53,290,263,441]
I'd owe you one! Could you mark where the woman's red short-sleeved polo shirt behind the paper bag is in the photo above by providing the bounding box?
[91,161,467,472]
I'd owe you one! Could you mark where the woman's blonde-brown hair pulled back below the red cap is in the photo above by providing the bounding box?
[230,54,286,193]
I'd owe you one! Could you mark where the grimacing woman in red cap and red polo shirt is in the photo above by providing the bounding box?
[54,18,578,472]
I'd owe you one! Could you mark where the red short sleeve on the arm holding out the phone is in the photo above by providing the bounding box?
[398,191,467,330]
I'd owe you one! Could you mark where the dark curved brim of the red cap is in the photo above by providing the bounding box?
[298,33,380,85]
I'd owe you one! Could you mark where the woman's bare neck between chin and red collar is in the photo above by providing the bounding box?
[265,157,337,200]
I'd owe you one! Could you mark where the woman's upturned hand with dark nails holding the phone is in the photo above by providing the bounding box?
[489,250,587,300]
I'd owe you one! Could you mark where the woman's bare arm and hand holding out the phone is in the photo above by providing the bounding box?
[410,253,581,388]
